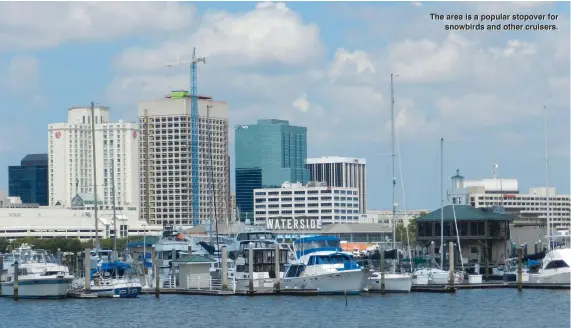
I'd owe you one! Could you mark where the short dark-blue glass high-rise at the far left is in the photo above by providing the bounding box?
[8,154,49,206]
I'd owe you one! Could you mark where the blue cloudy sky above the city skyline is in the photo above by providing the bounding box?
[0,2,570,213]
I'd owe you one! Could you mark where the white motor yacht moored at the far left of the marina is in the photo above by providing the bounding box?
[0,244,74,299]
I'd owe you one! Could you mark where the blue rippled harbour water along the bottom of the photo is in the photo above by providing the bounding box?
[0,289,570,328]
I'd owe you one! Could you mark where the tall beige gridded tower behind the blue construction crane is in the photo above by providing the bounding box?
[138,91,230,225]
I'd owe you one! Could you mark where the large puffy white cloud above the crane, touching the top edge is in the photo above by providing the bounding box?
[115,2,322,71]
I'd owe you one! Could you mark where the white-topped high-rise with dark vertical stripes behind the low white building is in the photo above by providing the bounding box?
[307,156,367,214]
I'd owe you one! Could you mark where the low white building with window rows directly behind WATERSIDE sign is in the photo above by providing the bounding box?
[254,182,359,225]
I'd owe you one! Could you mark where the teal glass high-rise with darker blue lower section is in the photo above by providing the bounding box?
[235,119,309,220]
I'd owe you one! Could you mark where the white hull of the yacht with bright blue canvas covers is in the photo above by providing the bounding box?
[281,269,365,294]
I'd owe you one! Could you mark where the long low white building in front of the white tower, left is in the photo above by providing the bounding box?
[0,206,162,240]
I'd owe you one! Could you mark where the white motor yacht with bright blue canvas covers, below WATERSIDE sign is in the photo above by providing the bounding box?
[282,236,365,294]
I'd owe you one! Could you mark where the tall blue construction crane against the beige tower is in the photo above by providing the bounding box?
[167,47,206,225]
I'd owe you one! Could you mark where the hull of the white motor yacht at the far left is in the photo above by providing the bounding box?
[1,277,73,298]
